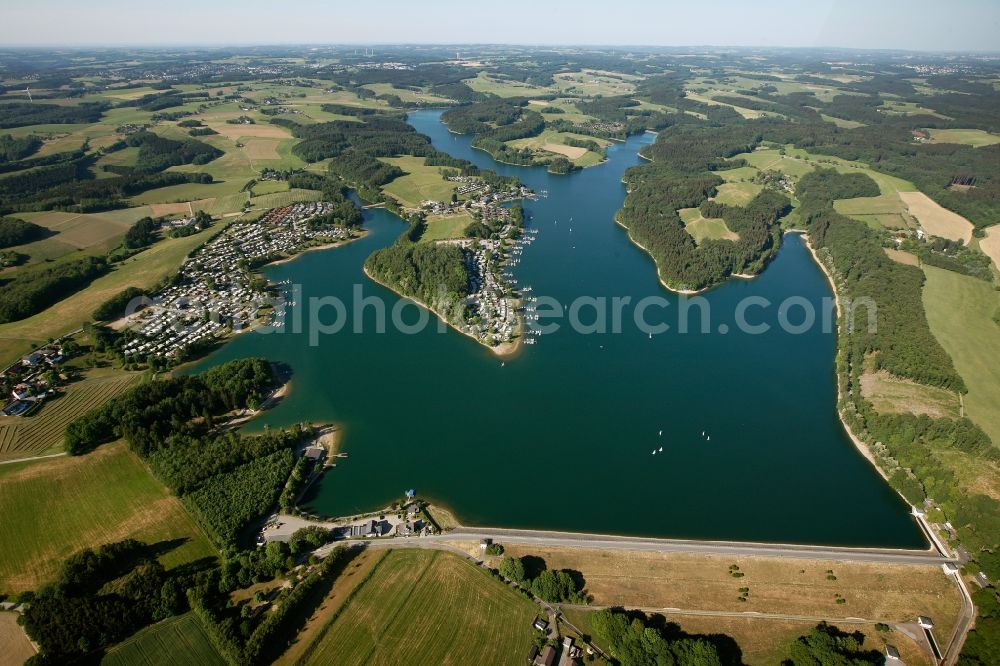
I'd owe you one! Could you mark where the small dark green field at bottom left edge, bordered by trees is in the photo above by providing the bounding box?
[101,613,226,666]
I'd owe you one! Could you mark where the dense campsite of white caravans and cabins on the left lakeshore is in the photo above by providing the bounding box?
[123,202,352,358]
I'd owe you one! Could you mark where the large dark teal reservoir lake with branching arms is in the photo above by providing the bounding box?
[196,111,926,548]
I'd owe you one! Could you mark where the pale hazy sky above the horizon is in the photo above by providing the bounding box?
[0,0,1000,51]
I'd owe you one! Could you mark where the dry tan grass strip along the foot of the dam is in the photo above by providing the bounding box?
[507,545,961,636]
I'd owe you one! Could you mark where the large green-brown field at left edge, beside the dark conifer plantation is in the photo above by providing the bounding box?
[0,442,215,592]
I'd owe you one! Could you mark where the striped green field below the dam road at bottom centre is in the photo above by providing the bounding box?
[303,550,538,664]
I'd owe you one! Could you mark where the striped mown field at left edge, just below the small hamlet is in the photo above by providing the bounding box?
[0,370,142,460]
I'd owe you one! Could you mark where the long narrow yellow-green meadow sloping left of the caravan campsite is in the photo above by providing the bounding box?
[0,222,223,367]
